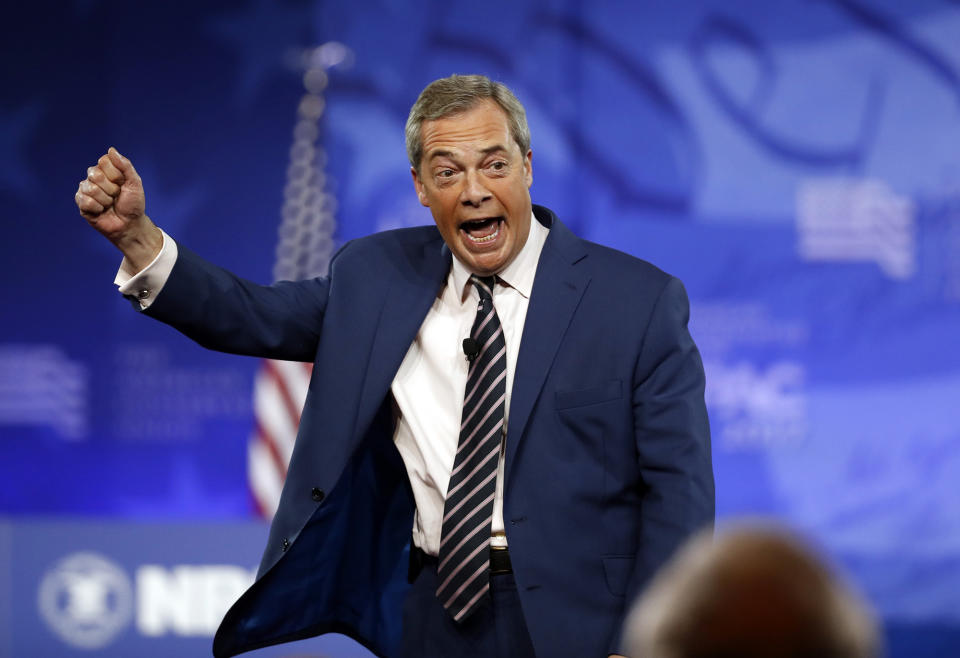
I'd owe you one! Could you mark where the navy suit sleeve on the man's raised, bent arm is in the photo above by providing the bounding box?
[144,245,333,362]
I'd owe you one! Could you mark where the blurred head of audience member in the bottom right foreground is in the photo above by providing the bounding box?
[625,524,882,658]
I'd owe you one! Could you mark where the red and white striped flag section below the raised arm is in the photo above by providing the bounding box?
[247,359,313,519]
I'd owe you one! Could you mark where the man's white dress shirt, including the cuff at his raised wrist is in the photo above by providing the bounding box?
[114,217,549,555]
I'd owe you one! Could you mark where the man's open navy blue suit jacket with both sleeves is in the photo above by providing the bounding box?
[147,206,714,658]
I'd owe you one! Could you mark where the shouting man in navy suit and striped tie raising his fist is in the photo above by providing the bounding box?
[76,76,714,658]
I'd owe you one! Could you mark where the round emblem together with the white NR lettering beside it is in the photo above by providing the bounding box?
[38,553,254,649]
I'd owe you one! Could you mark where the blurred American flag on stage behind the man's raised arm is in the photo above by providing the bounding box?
[247,42,352,519]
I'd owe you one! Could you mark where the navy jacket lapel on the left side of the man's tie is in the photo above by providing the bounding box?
[358,233,451,428]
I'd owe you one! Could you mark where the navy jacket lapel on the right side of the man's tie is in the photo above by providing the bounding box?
[506,206,590,477]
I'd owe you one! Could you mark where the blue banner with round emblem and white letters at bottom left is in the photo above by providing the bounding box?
[0,521,371,658]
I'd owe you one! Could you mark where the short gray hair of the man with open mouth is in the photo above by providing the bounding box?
[404,75,530,171]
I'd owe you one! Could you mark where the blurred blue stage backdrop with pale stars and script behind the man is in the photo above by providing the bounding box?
[0,0,960,656]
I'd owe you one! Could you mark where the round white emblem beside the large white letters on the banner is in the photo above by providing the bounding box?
[38,553,133,649]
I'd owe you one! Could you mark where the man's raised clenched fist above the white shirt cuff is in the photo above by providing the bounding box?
[75,146,163,271]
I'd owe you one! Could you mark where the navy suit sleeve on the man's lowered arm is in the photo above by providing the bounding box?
[611,278,715,652]
